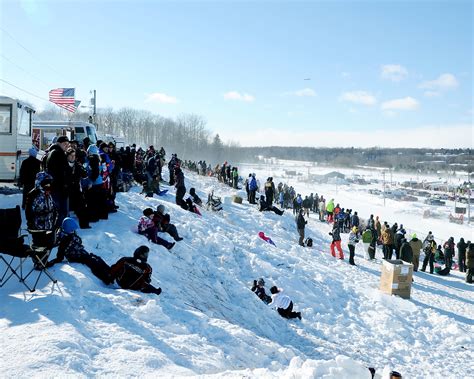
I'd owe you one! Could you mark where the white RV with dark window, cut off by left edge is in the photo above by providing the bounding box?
[0,96,35,180]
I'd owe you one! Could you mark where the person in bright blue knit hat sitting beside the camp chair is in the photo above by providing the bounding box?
[46,217,113,284]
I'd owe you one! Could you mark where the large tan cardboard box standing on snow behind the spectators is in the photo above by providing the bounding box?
[380,259,413,299]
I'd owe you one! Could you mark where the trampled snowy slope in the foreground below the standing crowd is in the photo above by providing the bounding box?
[0,171,474,378]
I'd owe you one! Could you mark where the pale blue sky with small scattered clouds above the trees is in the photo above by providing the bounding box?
[0,0,474,147]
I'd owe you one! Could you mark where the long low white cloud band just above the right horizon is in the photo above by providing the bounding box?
[219,123,473,148]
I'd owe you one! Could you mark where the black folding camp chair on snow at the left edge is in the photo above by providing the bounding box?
[0,205,57,292]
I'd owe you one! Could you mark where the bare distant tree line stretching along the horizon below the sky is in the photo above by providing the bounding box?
[36,107,474,172]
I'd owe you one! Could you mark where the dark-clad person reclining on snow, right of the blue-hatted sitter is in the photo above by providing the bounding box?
[110,246,161,295]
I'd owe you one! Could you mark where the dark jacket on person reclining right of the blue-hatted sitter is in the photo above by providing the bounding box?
[110,257,153,290]
